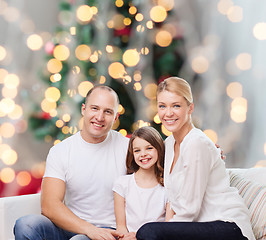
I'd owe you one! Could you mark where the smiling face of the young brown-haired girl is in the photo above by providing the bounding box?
[132,137,158,170]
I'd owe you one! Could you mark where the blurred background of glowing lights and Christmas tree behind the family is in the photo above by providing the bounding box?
[0,0,266,197]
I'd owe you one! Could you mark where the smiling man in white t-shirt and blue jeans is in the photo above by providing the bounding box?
[14,86,128,240]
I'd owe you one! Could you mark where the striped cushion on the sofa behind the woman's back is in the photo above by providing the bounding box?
[229,171,266,239]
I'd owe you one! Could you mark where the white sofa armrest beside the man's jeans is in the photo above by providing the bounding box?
[0,193,41,240]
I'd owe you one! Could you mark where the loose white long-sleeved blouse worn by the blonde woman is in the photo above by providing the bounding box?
[164,128,255,240]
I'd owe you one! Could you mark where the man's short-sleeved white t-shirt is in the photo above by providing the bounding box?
[44,130,129,227]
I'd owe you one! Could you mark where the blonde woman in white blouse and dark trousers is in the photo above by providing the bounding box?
[137,77,255,240]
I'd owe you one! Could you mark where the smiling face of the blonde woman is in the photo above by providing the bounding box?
[157,90,194,133]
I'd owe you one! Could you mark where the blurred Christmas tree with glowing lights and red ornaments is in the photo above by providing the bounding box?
[29,0,183,142]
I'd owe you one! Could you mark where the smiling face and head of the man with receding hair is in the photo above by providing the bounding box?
[81,88,118,143]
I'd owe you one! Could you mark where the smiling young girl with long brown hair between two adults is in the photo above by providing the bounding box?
[113,127,170,239]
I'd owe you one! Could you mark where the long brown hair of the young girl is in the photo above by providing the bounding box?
[126,127,165,186]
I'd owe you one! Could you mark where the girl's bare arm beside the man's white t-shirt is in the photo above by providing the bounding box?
[114,192,128,234]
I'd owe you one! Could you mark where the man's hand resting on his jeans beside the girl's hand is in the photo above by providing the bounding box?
[86,226,123,240]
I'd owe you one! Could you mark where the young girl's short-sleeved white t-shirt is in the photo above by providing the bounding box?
[113,174,167,232]
